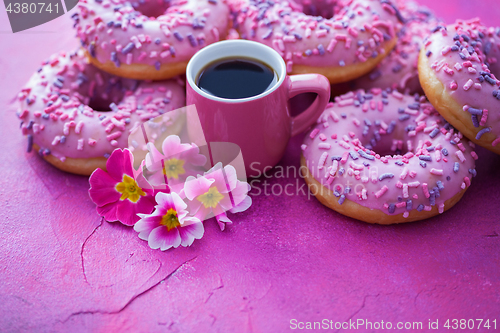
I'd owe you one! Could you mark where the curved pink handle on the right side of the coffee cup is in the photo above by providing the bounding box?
[288,74,330,136]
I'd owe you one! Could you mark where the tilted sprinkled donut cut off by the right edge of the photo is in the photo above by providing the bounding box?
[418,19,500,154]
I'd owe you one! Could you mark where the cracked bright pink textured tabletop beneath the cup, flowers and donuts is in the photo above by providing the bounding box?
[0,0,500,332]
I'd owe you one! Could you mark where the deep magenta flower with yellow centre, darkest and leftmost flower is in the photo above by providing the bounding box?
[89,149,155,225]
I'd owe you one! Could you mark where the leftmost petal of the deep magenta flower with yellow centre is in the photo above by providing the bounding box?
[89,169,121,206]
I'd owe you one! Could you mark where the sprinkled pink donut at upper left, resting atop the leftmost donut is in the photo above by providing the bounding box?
[73,0,229,80]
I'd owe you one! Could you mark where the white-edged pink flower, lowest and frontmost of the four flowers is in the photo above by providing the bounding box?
[134,192,204,251]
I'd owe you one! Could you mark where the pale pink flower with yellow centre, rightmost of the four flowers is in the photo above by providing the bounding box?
[183,163,252,230]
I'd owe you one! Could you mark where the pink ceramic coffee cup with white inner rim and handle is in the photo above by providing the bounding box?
[186,39,330,176]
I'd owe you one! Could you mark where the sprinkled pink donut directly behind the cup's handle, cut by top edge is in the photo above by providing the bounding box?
[232,0,401,83]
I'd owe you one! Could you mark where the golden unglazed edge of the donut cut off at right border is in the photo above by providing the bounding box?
[418,47,500,155]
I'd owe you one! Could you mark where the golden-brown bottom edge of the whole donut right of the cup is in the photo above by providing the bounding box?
[300,154,468,225]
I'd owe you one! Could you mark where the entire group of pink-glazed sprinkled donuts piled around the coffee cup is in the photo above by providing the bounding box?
[14,0,500,224]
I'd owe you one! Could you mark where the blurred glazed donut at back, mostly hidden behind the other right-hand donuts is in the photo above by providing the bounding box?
[332,2,440,95]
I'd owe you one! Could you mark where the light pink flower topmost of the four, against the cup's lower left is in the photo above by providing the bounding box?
[146,135,207,192]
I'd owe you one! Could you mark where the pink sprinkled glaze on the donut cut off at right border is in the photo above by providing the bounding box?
[425,19,500,146]
